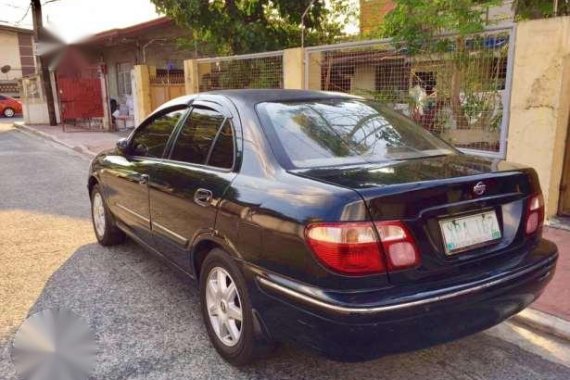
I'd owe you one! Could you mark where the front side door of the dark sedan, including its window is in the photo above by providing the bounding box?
[102,107,187,243]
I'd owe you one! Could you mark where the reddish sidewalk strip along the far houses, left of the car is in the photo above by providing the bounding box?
[14,122,130,157]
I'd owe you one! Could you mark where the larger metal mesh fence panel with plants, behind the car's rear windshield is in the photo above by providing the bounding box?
[305,26,515,157]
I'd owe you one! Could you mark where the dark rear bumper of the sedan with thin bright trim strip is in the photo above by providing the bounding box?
[243,240,558,361]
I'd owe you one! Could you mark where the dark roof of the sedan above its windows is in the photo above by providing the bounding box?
[156,89,359,111]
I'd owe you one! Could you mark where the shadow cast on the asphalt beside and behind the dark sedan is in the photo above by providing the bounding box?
[0,241,570,379]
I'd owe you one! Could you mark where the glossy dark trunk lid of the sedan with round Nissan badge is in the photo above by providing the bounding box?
[294,155,540,283]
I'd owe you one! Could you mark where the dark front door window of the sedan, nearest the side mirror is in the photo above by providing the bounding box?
[131,108,187,158]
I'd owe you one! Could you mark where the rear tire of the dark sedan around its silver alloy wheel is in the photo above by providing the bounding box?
[200,248,255,366]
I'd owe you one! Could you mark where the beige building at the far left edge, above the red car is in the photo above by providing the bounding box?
[0,25,36,96]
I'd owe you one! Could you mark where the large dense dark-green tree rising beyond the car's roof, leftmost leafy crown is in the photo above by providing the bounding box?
[152,0,353,55]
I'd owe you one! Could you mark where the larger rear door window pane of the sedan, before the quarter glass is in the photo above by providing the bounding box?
[170,108,225,164]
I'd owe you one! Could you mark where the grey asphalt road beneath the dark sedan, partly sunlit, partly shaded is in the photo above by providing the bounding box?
[0,121,570,380]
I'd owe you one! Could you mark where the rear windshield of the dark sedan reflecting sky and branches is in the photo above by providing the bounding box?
[257,99,457,168]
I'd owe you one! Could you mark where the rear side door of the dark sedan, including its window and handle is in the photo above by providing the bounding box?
[150,102,236,273]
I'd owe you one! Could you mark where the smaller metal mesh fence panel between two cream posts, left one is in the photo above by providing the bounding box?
[197,51,283,91]
